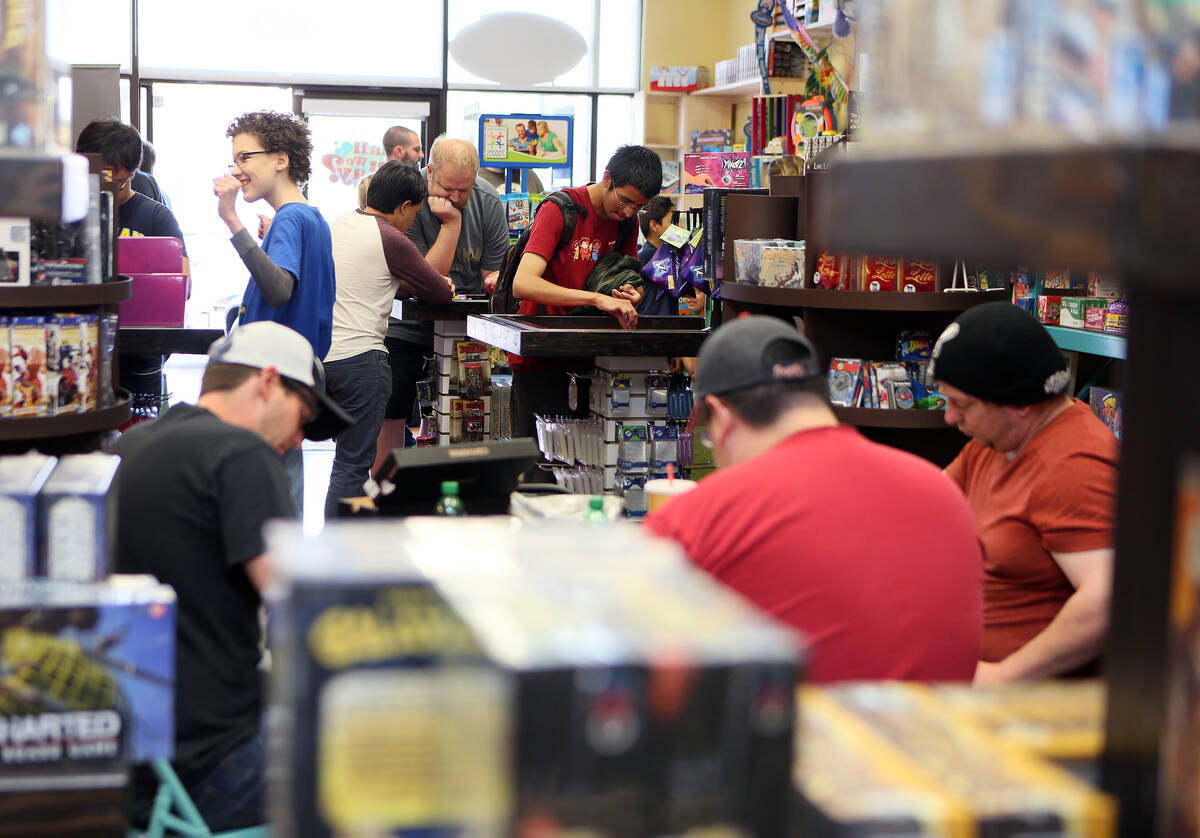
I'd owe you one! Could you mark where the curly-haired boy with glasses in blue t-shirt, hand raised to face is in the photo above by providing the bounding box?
[212,110,334,515]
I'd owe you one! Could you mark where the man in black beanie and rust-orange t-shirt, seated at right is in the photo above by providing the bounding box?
[932,303,1118,683]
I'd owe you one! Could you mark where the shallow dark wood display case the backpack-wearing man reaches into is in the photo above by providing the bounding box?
[467,315,708,358]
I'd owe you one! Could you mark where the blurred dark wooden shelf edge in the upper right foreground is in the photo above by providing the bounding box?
[810,142,1200,276]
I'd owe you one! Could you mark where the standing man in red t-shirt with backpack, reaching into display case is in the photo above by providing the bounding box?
[509,145,662,437]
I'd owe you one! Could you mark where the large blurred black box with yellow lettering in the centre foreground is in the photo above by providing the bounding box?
[269,519,799,838]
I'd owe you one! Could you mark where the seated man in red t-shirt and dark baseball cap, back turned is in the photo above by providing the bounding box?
[646,317,983,683]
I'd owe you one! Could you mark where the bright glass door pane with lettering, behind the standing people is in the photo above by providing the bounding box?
[301,96,433,222]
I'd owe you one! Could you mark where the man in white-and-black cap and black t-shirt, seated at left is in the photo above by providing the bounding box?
[113,322,349,831]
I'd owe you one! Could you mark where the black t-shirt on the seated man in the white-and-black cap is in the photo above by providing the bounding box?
[113,405,292,785]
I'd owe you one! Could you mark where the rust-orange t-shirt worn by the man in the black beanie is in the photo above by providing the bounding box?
[946,400,1120,662]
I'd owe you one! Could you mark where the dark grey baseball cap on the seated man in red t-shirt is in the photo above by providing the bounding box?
[692,315,824,399]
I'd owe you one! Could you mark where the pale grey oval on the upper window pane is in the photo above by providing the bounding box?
[450,12,588,85]
